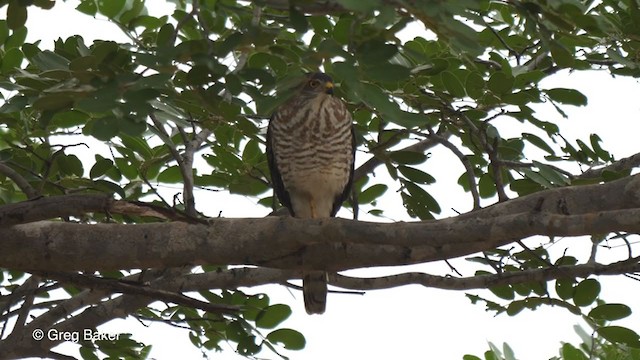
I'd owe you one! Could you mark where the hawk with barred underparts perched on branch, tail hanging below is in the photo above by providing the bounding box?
[267,72,355,314]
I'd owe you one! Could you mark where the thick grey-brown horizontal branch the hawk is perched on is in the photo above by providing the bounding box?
[0,176,640,271]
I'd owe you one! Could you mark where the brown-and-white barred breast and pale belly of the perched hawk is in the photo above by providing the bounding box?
[270,94,354,218]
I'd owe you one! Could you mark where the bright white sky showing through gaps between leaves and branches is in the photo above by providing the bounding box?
[8,0,640,360]
